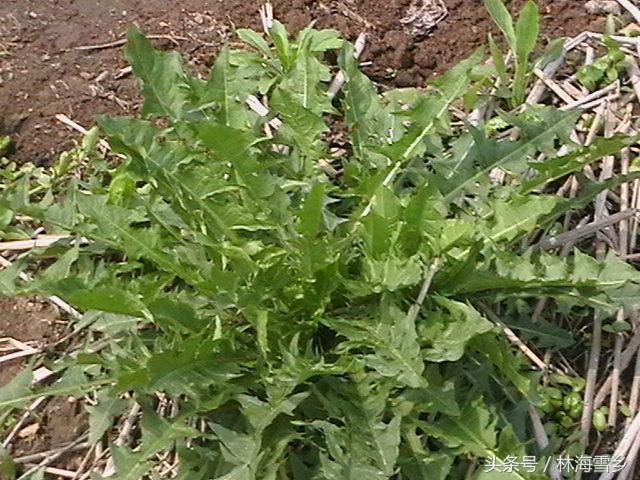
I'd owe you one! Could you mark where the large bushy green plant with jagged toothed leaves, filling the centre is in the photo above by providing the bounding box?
[0,17,640,480]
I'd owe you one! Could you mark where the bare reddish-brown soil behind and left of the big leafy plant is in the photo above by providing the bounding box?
[0,0,603,474]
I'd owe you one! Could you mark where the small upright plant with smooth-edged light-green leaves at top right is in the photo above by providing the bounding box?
[484,0,540,107]
